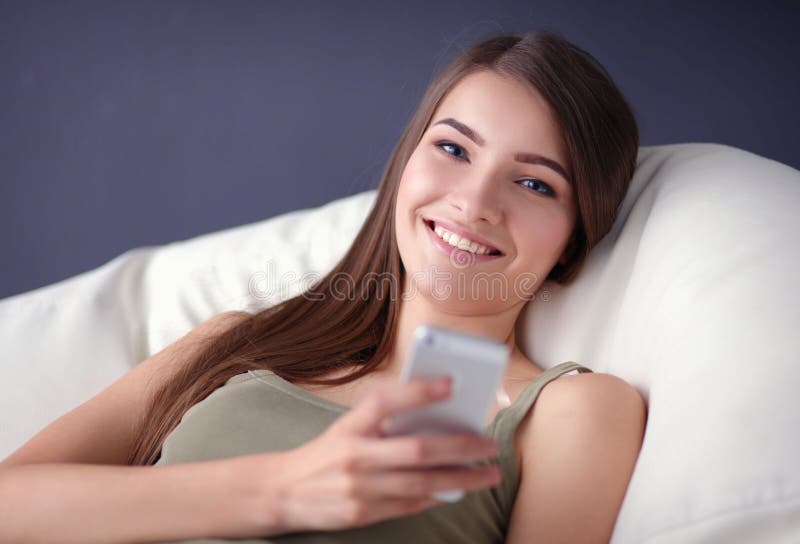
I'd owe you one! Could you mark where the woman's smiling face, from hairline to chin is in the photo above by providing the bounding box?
[395,71,576,313]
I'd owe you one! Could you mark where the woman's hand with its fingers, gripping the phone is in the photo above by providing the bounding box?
[251,378,500,536]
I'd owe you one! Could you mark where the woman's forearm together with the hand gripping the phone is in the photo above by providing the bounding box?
[0,380,499,543]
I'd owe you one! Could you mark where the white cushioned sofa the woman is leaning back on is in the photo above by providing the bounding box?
[0,144,800,544]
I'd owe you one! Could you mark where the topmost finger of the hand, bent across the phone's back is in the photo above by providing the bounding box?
[335,378,450,436]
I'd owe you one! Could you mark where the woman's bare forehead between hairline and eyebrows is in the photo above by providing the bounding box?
[430,70,569,164]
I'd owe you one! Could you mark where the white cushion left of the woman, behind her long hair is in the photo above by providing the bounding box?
[0,191,374,459]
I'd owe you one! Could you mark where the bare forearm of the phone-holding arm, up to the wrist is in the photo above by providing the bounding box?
[0,456,269,544]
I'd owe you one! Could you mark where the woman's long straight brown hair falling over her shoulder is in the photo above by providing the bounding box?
[128,28,639,465]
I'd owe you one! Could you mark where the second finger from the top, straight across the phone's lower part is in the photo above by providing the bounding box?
[348,433,498,470]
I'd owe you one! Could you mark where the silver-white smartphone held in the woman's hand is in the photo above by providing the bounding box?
[386,325,510,502]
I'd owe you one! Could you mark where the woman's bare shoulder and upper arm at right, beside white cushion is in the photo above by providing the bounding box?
[507,374,647,544]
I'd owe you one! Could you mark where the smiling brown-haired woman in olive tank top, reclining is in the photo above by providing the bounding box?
[0,32,645,543]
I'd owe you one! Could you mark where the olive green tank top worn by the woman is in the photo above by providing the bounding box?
[155,361,591,544]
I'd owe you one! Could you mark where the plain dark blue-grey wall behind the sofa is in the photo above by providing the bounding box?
[0,0,800,297]
